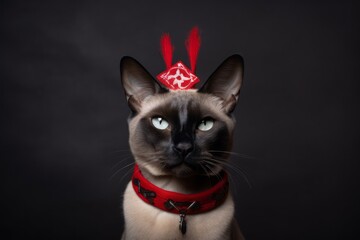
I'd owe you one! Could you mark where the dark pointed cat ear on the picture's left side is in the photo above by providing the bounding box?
[120,57,167,112]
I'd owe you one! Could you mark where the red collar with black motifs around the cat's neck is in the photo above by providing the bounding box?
[132,164,229,214]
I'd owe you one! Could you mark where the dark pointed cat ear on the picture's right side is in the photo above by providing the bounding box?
[199,54,244,113]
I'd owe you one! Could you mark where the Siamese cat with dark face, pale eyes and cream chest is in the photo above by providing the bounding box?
[120,55,244,240]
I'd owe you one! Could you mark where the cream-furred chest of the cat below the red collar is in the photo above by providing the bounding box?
[124,184,234,240]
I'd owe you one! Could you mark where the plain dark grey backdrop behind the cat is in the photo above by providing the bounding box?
[0,0,360,239]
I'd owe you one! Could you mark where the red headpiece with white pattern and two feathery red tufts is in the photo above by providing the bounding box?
[157,27,201,90]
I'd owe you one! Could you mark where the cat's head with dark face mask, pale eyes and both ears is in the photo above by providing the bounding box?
[120,55,243,177]
